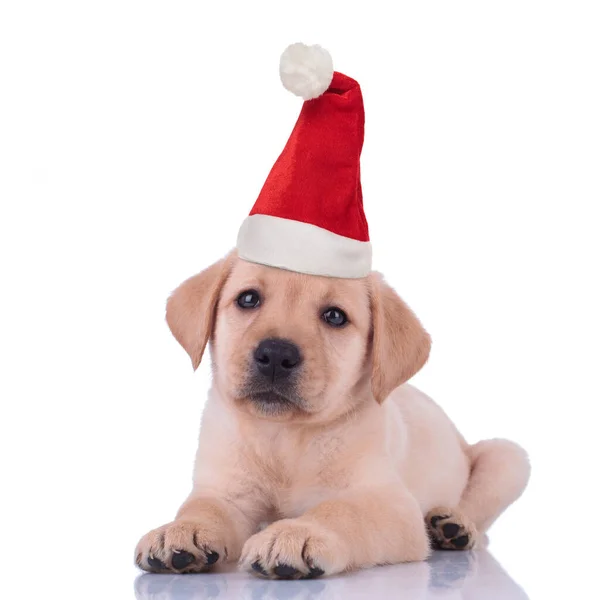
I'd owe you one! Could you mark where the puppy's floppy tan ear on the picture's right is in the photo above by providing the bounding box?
[370,273,431,403]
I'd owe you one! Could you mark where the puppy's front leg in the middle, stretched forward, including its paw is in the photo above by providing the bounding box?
[240,483,430,579]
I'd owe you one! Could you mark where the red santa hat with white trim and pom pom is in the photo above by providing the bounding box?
[237,44,371,278]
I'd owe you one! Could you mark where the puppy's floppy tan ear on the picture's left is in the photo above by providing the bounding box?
[167,253,233,370]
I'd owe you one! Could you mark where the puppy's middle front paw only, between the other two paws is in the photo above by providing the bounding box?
[240,519,350,579]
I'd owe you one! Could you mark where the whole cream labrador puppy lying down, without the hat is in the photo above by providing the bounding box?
[135,252,529,579]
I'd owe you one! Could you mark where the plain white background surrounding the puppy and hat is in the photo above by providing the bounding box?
[0,0,600,598]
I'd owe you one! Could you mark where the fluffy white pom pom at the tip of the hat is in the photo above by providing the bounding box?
[279,43,333,100]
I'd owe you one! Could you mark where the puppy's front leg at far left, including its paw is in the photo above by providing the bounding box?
[135,492,258,573]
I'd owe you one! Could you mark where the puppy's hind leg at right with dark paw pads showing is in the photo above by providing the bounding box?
[427,439,530,550]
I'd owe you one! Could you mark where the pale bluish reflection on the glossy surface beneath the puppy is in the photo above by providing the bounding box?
[135,550,528,600]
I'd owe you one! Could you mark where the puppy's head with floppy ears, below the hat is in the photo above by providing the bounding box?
[167,253,430,420]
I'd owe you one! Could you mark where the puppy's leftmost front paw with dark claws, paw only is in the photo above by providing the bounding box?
[135,521,227,573]
